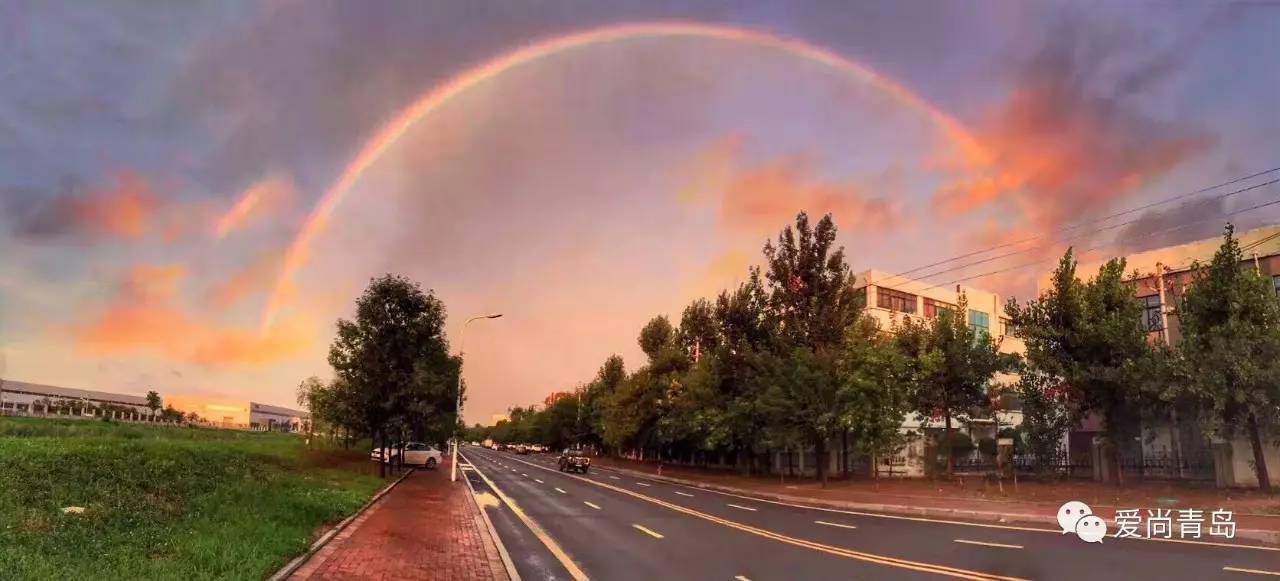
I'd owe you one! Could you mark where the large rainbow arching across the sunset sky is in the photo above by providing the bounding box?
[262,22,980,329]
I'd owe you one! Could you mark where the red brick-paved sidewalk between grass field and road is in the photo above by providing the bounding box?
[289,459,509,581]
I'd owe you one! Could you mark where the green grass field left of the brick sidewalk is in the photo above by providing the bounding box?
[0,417,383,580]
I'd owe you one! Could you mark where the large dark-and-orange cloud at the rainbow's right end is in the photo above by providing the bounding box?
[934,17,1215,229]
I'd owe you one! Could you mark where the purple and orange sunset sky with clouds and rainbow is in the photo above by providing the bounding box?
[0,0,1280,422]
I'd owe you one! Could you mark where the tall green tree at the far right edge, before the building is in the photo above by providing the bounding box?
[1178,225,1280,491]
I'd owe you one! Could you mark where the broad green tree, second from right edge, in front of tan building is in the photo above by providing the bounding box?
[1005,248,1151,482]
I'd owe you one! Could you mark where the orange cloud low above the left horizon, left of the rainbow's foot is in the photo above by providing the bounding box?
[73,265,312,367]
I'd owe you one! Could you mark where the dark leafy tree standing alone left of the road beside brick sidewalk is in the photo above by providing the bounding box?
[329,274,461,476]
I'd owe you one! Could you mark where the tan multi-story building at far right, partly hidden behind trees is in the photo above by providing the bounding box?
[1037,225,1280,486]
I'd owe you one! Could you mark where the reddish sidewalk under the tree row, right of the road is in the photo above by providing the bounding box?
[595,457,1280,544]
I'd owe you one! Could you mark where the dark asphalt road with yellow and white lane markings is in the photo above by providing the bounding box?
[463,448,1280,581]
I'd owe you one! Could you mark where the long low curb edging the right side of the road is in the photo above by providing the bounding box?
[608,466,1280,545]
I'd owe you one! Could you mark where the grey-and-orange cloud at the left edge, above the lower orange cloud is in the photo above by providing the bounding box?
[9,171,161,241]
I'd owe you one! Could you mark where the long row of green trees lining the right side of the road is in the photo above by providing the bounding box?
[468,214,1280,488]
